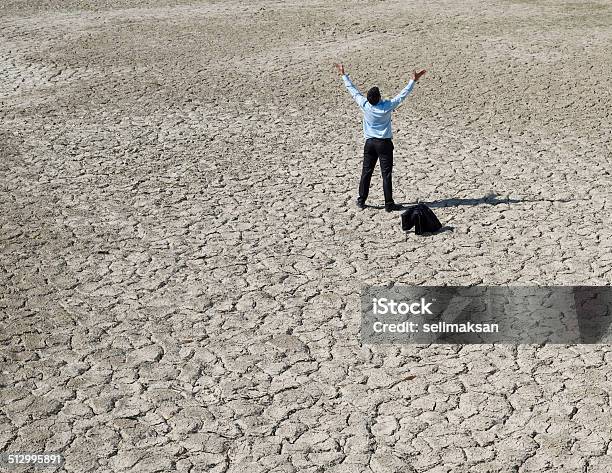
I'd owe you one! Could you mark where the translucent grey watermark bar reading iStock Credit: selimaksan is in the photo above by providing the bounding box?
[361,285,612,344]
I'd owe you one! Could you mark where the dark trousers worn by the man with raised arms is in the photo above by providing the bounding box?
[357,138,393,205]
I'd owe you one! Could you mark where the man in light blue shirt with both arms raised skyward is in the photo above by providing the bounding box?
[335,64,425,212]
